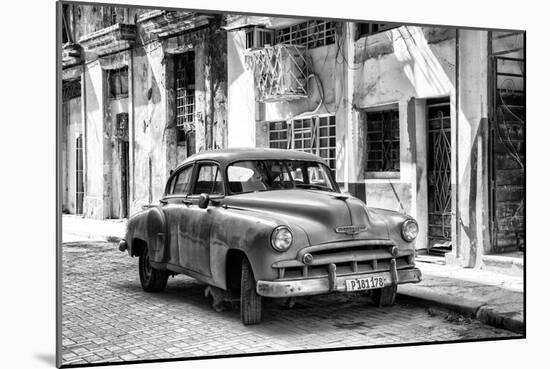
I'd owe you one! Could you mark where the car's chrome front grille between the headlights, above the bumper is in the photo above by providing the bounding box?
[274,245,414,279]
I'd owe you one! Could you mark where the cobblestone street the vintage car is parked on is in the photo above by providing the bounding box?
[62,241,515,365]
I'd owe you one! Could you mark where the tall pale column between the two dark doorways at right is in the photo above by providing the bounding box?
[447,30,489,267]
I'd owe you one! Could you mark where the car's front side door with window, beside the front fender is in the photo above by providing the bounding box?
[178,161,224,277]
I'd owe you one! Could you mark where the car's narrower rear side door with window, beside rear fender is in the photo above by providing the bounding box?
[161,164,194,266]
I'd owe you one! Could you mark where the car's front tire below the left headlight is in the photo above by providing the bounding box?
[241,257,263,325]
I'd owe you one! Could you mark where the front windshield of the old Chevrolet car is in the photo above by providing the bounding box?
[227,160,336,194]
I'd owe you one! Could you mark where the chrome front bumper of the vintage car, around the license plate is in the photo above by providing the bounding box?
[256,267,422,297]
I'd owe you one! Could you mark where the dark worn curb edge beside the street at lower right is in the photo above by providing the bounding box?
[398,291,525,334]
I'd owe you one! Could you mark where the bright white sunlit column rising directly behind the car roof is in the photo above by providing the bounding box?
[227,31,256,147]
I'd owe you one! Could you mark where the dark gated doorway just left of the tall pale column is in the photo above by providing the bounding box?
[426,97,452,256]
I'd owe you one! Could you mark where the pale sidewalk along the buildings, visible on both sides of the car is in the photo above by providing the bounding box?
[62,215,525,333]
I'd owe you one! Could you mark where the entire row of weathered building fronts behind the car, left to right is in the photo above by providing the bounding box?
[61,4,525,267]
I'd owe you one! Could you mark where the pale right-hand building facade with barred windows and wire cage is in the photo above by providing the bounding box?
[226,15,525,267]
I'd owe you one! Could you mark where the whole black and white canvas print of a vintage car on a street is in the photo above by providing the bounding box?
[52,1,532,368]
